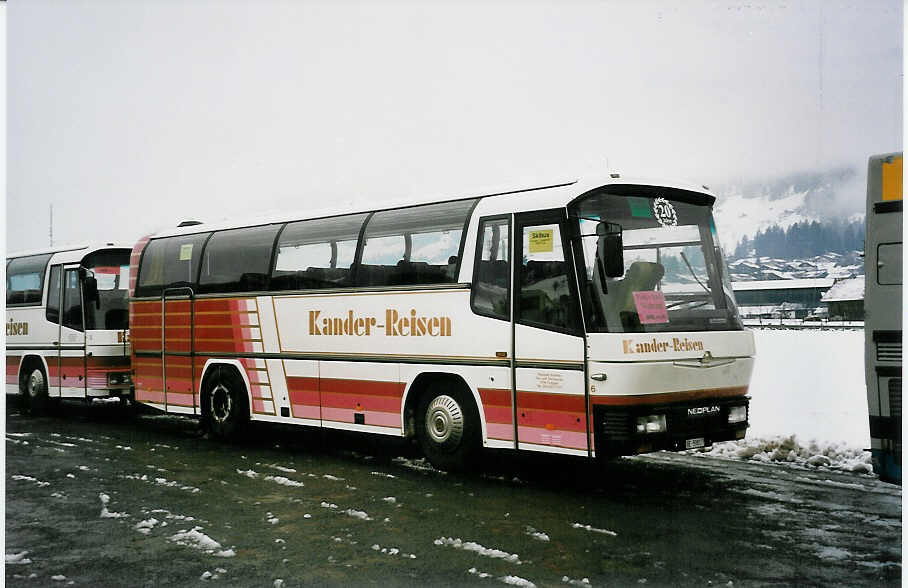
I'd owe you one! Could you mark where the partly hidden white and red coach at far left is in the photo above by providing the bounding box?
[6,243,132,412]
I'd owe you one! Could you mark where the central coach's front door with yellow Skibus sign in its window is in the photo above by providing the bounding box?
[514,209,589,456]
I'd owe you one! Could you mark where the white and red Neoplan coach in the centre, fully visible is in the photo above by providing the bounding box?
[130,174,754,468]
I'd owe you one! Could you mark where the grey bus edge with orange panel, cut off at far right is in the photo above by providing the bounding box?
[864,153,903,483]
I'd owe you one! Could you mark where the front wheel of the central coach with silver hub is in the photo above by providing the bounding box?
[416,382,480,472]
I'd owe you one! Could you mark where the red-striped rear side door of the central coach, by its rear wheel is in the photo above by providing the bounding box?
[161,287,197,414]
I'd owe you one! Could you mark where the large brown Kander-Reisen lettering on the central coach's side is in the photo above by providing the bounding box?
[309,308,451,337]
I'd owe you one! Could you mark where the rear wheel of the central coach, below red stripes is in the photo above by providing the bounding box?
[202,367,249,439]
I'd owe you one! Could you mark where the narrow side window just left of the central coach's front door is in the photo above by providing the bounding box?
[471,218,511,320]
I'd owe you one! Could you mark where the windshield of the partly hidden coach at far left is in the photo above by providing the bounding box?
[82,251,129,330]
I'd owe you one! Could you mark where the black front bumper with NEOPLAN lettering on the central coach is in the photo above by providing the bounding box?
[593,396,750,456]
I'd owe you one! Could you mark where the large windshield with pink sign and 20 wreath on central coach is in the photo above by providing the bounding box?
[572,188,742,333]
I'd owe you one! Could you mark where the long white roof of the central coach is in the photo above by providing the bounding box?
[140,173,715,238]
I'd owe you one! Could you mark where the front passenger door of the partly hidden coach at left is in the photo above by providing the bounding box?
[59,266,88,398]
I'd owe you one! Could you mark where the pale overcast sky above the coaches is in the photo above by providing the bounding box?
[6,0,903,250]
